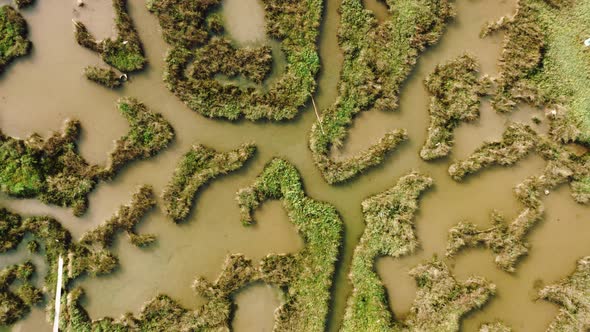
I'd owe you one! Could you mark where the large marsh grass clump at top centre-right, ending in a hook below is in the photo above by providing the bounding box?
[309,0,453,184]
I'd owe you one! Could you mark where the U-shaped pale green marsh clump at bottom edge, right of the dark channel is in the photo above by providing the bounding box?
[342,172,495,332]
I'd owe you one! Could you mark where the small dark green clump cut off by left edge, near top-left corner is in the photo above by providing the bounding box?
[0,5,31,74]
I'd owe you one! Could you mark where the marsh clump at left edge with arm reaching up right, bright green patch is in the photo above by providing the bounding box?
[0,99,174,216]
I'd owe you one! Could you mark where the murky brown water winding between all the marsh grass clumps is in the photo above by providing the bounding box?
[0,0,590,331]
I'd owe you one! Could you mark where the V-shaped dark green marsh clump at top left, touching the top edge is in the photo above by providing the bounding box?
[74,0,147,72]
